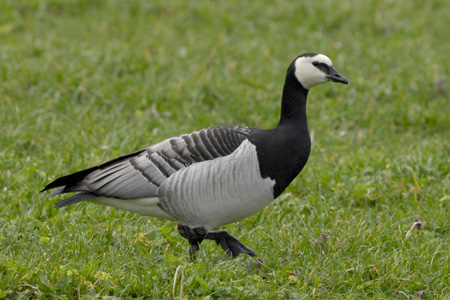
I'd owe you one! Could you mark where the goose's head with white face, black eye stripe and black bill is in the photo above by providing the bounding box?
[294,53,348,90]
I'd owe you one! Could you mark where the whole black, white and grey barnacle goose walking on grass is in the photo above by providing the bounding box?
[41,53,348,259]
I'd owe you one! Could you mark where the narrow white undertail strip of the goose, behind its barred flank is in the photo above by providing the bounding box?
[88,197,175,220]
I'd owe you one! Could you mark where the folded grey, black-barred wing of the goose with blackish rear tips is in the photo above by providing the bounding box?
[42,126,253,207]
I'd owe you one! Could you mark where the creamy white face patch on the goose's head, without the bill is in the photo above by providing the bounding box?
[295,54,333,90]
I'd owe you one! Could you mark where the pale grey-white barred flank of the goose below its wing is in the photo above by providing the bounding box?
[158,140,275,230]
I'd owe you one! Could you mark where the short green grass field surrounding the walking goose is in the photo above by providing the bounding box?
[0,0,450,300]
